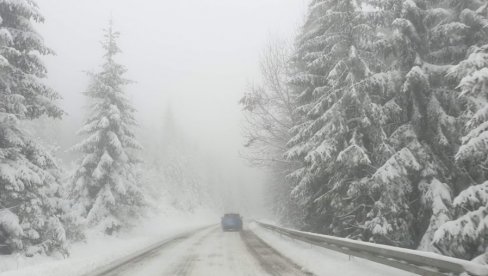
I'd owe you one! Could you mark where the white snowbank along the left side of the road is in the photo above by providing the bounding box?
[0,210,218,276]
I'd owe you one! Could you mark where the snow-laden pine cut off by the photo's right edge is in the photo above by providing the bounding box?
[433,15,488,259]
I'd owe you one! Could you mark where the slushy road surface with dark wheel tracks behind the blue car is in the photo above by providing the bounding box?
[103,227,311,276]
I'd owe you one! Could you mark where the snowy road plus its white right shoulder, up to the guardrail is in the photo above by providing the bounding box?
[90,223,420,276]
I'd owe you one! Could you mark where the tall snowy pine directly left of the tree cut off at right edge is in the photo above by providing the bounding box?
[363,0,468,249]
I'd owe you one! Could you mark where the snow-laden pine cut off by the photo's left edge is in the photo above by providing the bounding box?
[0,0,66,255]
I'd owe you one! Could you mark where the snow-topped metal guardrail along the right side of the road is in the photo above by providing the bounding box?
[256,221,488,276]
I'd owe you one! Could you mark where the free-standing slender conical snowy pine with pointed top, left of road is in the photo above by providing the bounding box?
[71,22,144,234]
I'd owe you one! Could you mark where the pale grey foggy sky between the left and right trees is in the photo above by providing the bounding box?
[38,0,306,216]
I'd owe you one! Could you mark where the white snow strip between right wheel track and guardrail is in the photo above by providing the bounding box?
[249,223,416,276]
